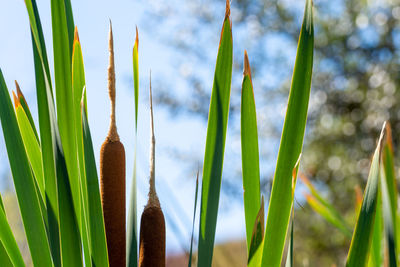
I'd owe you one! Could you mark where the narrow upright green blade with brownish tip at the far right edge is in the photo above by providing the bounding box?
[381,123,397,267]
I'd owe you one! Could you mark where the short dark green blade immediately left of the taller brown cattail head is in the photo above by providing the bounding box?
[82,93,108,267]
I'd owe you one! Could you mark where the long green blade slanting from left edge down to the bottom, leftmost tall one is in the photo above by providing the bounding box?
[0,70,53,266]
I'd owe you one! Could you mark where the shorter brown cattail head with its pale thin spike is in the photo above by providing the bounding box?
[139,73,165,267]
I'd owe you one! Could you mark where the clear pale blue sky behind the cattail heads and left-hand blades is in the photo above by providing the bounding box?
[0,0,245,255]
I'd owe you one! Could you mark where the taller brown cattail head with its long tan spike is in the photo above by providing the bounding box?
[100,22,126,267]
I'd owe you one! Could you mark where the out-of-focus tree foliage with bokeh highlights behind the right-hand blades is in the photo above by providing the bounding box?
[143,0,400,266]
